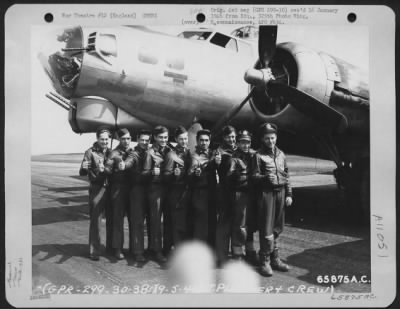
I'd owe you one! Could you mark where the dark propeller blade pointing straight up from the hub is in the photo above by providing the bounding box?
[258,26,278,68]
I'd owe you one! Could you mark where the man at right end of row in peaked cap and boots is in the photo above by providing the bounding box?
[251,123,292,276]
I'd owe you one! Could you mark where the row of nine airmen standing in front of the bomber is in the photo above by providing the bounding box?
[80,123,292,276]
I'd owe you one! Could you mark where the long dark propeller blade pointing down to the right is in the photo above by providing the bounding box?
[268,81,348,133]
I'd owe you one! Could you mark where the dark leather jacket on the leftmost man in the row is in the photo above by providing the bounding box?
[79,142,111,185]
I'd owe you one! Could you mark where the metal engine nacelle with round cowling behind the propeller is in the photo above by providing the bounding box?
[251,43,369,133]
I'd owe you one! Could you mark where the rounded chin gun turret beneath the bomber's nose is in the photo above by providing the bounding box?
[68,97,151,133]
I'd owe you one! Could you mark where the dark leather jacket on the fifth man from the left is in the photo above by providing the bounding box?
[163,145,191,185]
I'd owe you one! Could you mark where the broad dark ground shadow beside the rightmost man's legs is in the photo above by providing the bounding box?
[286,185,369,238]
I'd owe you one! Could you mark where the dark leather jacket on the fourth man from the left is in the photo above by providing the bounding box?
[142,145,171,184]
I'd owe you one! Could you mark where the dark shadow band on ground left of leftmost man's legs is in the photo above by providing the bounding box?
[32,203,89,226]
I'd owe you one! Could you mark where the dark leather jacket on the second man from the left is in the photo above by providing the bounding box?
[105,145,133,185]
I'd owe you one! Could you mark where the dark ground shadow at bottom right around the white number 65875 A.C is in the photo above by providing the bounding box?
[287,239,371,286]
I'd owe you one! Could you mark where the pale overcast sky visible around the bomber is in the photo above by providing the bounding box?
[31,25,369,154]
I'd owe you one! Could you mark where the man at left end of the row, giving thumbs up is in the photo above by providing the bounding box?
[79,128,112,261]
